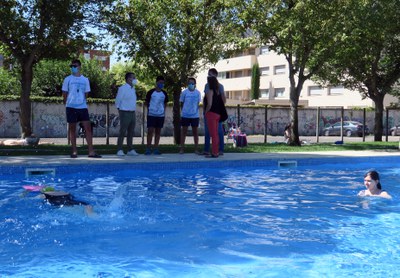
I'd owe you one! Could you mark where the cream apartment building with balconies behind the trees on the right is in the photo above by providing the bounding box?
[197,46,399,108]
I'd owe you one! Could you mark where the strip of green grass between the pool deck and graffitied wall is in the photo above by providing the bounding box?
[0,142,399,156]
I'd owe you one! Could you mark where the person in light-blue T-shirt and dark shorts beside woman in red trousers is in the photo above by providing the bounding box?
[179,77,201,154]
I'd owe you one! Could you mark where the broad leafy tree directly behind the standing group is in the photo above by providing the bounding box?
[104,0,241,144]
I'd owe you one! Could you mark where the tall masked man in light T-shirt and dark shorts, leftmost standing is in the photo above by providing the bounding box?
[62,60,101,158]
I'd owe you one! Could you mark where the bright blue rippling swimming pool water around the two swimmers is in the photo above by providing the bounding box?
[0,157,400,277]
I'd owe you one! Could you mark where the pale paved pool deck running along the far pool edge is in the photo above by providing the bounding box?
[0,150,400,166]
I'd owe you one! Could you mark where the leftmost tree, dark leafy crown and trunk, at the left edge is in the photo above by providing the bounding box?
[0,0,108,138]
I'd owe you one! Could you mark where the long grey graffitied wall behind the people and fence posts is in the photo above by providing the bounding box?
[0,101,400,138]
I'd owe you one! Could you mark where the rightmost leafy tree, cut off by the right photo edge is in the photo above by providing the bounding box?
[319,0,400,141]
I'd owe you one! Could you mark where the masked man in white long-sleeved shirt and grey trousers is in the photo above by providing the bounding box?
[115,72,138,156]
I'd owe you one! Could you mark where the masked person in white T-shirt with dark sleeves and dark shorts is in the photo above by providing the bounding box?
[144,76,168,155]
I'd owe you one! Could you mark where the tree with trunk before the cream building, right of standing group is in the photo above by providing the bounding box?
[237,0,340,146]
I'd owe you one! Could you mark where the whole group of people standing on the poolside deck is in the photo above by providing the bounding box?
[62,60,227,158]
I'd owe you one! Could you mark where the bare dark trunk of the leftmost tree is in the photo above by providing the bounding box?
[19,58,33,138]
